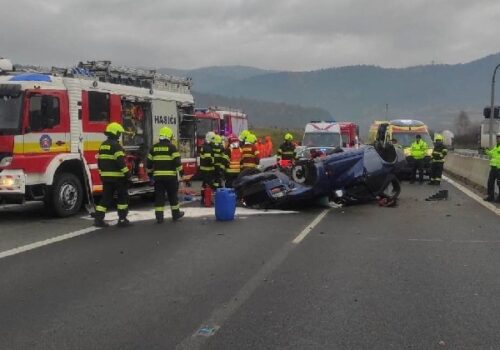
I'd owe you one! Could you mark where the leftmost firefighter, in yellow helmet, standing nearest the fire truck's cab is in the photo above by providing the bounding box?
[94,123,131,227]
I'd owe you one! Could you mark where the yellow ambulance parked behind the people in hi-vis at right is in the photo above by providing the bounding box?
[368,119,434,176]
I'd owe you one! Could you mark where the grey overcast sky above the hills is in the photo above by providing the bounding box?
[0,0,500,70]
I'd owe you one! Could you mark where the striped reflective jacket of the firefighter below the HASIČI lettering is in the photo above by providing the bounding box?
[146,140,182,180]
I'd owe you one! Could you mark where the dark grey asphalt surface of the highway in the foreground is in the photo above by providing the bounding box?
[0,180,500,350]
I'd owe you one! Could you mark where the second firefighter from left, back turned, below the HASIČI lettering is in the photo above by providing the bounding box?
[146,126,184,224]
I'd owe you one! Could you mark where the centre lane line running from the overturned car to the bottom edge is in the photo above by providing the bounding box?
[175,209,329,350]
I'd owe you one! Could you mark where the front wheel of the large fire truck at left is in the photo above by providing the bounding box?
[50,173,83,217]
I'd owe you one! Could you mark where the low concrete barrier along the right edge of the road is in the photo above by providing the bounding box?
[444,152,490,188]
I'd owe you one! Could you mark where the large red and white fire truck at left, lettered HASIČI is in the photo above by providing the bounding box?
[0,60,196,217]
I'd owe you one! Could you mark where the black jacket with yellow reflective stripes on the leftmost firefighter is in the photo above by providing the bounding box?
[97,137,130,182]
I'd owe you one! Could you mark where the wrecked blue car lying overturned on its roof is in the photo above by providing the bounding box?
[234,144,405,208]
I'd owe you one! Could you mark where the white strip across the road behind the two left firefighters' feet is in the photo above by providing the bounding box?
[81,206,298,222]
